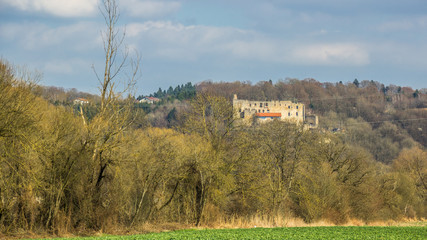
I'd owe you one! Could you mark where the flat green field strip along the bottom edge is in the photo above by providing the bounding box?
[34,227,427,240]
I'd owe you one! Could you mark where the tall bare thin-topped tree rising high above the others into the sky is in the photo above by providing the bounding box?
[81,0,141,229]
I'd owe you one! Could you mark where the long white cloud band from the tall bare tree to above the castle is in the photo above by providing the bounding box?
[127,21,369,66]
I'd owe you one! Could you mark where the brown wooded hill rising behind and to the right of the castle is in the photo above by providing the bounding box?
[197,79,427,163]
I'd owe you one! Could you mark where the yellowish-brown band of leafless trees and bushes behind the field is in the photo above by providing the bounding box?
[0,61,427,234]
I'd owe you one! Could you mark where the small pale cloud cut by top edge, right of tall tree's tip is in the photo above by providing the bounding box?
[120,0,181,18]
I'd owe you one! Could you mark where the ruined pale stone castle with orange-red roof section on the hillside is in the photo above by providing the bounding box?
[233,94,318,128]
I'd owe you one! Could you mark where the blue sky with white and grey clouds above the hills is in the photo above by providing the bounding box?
[0,0,427,95]
